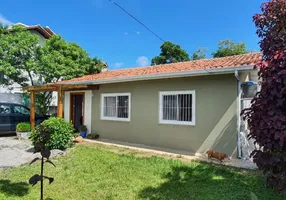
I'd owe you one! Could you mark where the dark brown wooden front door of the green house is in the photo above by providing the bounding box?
[70,93,84,131]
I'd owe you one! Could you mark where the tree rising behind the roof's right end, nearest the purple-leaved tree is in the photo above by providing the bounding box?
[212,40,248,58]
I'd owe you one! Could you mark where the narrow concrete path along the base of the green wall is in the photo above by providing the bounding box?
[84,139,257,169]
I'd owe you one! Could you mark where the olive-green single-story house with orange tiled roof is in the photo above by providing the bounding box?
[25,53,262,156]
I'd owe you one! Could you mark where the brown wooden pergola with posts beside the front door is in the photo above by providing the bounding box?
[23,84,99,130]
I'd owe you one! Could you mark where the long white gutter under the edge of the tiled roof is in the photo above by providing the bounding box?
[58,65,254,85]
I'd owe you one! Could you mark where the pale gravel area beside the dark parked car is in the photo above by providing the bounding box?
[0,137,66,169]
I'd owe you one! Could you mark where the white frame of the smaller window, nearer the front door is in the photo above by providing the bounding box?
[100,93,131,122]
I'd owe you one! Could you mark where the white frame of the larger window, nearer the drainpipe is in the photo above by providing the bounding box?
[159,90,196,126]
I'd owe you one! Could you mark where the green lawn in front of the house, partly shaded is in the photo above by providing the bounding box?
[0,144,285,200]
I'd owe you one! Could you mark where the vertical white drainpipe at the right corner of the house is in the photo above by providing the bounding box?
[234,70,242,158]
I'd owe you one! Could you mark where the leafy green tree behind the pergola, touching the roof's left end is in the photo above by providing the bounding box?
[36,35,103,113]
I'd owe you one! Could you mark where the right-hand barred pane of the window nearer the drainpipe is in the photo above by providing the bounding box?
[178,94,192,122]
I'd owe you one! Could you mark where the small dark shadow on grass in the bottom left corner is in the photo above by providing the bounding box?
[0,180,29,197]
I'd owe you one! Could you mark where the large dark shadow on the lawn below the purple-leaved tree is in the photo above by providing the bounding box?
[139,164,267,200]
